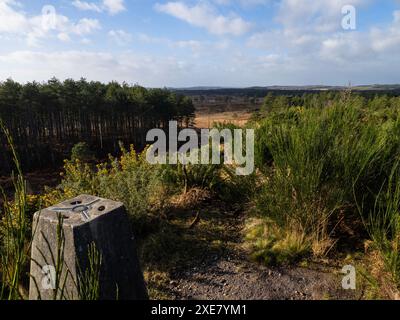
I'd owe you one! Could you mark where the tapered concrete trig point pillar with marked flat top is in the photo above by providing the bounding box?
[29,195,148,300]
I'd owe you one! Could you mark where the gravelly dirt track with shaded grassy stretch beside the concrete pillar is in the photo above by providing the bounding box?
[143,191,361,300]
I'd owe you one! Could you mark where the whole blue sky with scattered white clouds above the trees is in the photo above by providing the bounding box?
[0,0,400,87]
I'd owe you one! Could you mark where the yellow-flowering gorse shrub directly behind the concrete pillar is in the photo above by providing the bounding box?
[54,146,167,234]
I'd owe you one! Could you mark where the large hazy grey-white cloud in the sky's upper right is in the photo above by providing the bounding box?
[247,0,400,66]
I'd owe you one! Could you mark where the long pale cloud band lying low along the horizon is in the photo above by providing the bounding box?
[0,41,400,87]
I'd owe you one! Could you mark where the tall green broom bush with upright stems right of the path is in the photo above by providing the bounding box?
[250,94,400,266]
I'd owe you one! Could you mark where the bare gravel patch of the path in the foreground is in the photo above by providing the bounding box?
[169,252,354,300]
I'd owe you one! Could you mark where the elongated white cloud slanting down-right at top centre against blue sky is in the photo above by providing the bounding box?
[155,2,251,36]
